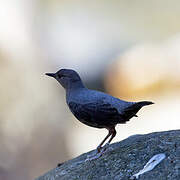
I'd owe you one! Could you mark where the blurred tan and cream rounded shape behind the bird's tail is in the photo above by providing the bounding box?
[105,38,180,100]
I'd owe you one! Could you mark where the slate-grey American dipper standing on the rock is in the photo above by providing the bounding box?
[46,69,154,155]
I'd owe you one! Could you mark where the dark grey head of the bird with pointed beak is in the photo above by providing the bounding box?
[46,69,82,89]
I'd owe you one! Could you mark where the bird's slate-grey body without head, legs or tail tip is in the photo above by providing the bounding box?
[67,88,150,128]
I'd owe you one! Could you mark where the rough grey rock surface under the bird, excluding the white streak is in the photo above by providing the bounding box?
[36,130,180,180]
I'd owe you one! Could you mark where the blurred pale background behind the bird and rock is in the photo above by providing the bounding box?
[0,0,180,180]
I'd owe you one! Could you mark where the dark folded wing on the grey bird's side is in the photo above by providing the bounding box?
[68,101,120,121]
